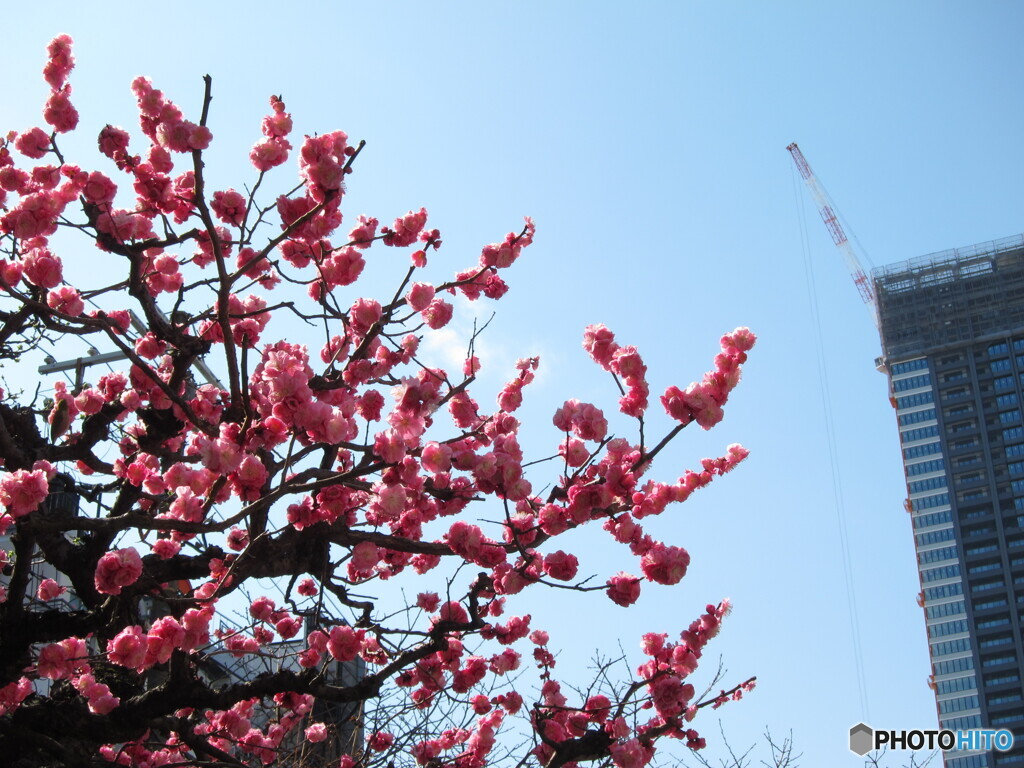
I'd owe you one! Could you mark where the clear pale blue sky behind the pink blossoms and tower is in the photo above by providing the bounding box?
[0,1,1024,766]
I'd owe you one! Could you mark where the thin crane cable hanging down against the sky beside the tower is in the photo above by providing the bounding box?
[790,163,870,721]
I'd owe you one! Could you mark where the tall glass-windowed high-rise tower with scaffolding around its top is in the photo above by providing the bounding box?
[872,237,1024,768]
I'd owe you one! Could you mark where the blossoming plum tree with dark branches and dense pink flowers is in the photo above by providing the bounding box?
[0,36,755,768]
